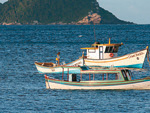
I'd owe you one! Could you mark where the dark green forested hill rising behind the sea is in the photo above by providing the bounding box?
[0,0,131,24]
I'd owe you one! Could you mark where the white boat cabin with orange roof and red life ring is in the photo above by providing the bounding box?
[81,39,123,59]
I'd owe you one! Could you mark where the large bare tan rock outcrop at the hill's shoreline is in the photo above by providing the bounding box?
[77,13,101,25]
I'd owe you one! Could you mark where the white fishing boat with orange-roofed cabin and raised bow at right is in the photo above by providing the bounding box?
[66,39,149,68]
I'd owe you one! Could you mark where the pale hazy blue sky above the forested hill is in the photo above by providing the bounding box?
[0,0,150,24]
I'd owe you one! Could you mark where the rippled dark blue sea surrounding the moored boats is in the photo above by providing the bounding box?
[0,25,150,113]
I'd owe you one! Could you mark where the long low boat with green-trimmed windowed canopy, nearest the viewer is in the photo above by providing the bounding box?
[45,68,150,90]
